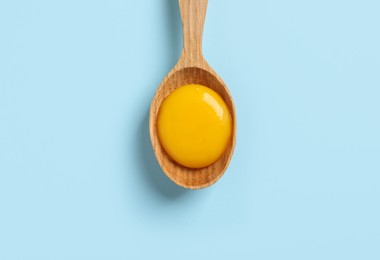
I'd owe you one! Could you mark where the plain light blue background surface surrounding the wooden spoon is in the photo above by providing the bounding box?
[0,0,380,260]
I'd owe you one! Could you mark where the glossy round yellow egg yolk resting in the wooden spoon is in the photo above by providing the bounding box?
[157,84,232,168]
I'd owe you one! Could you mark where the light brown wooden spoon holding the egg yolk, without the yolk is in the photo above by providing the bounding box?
[149,0,236,189]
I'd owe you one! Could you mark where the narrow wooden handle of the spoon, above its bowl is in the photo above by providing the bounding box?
[179,0,208,67]
